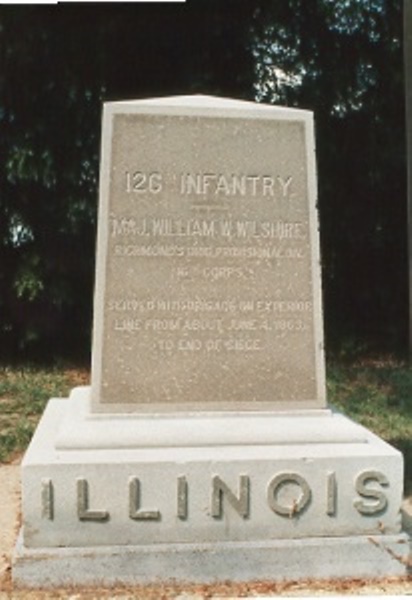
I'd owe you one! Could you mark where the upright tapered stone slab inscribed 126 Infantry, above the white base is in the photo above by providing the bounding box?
[92,97,325,412]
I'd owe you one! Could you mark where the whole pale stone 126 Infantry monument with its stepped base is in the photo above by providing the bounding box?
[13,96,408,587]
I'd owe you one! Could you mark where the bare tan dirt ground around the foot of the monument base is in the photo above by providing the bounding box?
[0,460,412,600]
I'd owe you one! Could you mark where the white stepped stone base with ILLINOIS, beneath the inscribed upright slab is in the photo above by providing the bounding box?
[13,388,409,587]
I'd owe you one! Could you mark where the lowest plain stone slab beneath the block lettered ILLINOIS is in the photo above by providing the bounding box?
[13,534,408,588]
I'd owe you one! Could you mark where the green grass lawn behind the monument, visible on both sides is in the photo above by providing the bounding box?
[0,359,412,494]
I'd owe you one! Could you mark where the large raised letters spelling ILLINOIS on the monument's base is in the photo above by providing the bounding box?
[41,470,389,522]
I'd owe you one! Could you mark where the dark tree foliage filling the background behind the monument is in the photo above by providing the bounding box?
[0,0,407,356]
